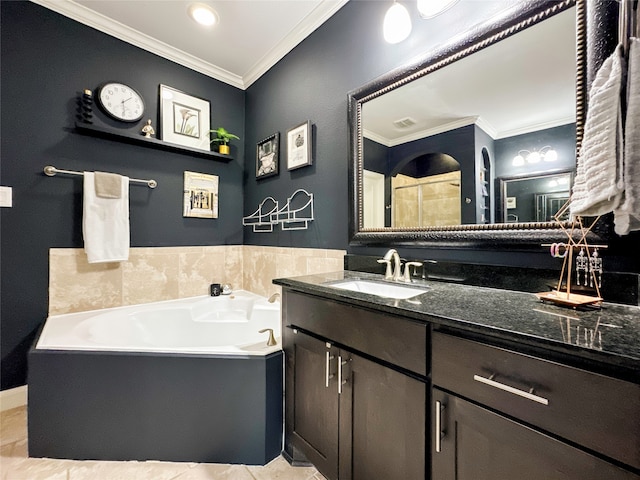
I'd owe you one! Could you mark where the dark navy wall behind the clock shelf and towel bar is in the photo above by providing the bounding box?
[0,1,244,389]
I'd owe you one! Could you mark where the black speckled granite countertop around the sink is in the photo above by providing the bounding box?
[273,271,640,382]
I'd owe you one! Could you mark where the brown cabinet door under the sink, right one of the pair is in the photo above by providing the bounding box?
[337,350,426,480]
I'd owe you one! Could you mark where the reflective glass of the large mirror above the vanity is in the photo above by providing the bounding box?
[361,8,576,229]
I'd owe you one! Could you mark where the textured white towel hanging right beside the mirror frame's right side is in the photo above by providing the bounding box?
[570,45,624,217]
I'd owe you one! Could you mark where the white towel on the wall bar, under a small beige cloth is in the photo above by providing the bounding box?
[82,172,129,263]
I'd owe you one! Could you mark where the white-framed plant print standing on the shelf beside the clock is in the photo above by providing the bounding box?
[160,85,211,151]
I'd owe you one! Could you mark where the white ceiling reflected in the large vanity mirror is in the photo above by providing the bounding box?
[363,8,576,146]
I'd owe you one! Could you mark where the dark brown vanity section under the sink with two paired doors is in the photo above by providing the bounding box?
[283,290,427,480]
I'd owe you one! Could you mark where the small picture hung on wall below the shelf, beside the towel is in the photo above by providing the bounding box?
[182,171,218,218]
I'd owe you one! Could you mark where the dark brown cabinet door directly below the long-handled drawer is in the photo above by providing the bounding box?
[432,388,638,480]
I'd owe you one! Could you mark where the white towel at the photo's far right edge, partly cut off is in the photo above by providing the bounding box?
[613,38,640,235]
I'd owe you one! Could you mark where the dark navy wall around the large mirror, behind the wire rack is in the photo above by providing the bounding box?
[245,0,640,272]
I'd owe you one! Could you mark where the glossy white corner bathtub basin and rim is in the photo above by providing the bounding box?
[36,290,281,355]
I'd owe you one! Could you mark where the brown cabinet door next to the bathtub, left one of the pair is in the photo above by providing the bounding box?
[284,328,338,480]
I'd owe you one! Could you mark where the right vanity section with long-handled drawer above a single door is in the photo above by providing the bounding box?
[431,332,640,480]
